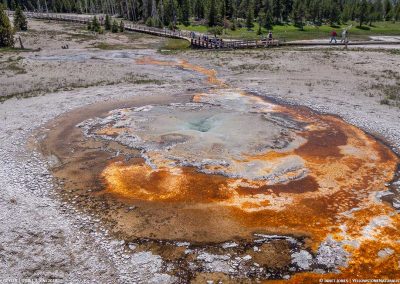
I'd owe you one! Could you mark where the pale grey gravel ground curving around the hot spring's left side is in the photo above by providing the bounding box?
[0,72,197,283]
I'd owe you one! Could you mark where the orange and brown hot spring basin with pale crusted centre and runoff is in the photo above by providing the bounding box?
[41,57,400,283]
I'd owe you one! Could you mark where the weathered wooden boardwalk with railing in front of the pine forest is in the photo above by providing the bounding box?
[7,11,279,49]
